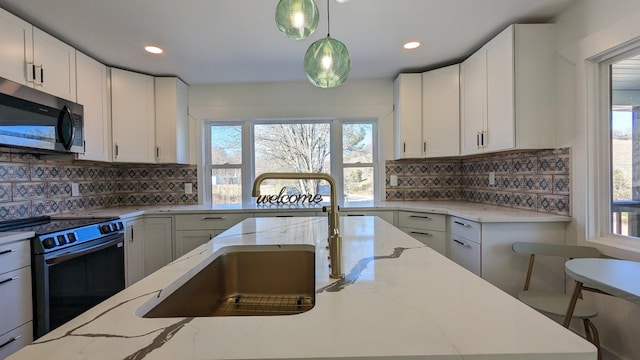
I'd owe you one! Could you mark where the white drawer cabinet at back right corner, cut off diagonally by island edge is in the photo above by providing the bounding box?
[398,211,447,256]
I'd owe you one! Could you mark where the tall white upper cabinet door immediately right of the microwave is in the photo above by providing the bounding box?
[76,52,111,161]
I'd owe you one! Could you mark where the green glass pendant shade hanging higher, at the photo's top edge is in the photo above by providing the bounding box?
[276,0,320,40]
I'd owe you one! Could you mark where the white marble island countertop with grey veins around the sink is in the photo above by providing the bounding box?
[9,217,596,360]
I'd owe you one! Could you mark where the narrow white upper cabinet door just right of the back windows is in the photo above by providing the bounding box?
[393,74,422,159]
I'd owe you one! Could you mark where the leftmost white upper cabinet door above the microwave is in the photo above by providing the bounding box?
[0,9,33,86]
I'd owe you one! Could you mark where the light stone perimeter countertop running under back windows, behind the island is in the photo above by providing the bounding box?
[57,201,571,223]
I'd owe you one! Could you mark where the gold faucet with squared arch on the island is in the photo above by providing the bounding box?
[251,172,344,279]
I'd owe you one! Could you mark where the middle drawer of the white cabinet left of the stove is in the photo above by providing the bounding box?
[0,266,33,334]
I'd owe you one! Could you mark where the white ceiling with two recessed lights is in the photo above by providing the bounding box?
[0,0,574,84]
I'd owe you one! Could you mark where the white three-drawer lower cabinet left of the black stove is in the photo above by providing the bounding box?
[0,239,33,359]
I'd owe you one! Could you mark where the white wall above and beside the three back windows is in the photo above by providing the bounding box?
[189,79,393,200]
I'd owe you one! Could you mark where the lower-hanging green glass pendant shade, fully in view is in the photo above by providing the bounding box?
[304,36,351,88]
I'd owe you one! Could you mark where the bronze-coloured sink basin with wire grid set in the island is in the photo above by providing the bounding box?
[142,245,315,318]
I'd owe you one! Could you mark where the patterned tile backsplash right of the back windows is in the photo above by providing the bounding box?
[385,148,571,215]
